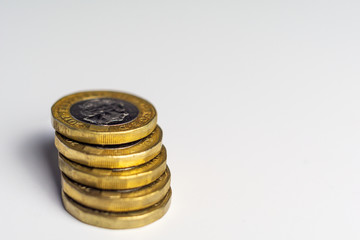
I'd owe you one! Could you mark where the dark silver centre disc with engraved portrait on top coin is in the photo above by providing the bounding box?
[70,98,139,125]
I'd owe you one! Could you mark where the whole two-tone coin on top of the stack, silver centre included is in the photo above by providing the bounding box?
[51,91,157,145]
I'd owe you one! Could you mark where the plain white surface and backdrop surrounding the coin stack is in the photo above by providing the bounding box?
[0,0,360,240]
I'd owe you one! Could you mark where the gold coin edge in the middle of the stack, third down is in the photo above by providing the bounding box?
[59,146,166,190]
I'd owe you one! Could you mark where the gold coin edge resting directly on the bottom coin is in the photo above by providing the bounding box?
[61,168,170,212]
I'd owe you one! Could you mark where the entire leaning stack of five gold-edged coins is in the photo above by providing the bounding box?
[51,91,171,229]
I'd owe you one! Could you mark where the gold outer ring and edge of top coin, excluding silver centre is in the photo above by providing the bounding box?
[51,91,157,145]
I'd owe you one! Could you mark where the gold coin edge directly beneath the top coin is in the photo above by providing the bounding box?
[55,126,162,168]
